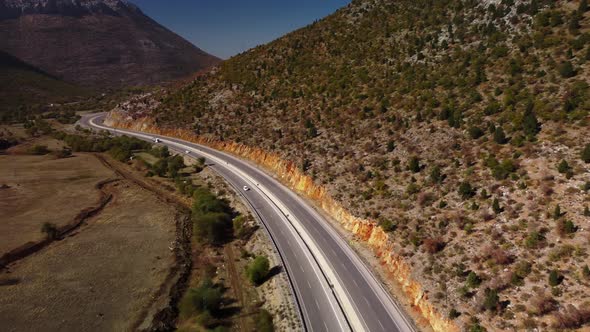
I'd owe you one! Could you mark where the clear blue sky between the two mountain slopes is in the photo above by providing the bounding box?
[131,0,350,59]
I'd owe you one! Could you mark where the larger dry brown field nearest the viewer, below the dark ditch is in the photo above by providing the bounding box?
[0,180,176,331]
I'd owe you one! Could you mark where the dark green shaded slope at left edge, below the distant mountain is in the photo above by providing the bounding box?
[0,51,92,113]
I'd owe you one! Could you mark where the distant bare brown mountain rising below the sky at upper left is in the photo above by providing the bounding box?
[0,0,219,86]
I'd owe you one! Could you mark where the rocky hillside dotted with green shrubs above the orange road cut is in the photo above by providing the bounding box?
[113,0,590,331]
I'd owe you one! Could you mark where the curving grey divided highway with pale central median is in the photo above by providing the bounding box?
[80,113,417,332]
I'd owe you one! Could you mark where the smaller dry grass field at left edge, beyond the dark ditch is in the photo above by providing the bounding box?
[0,154,114,255]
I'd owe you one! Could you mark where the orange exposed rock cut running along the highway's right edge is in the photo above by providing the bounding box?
[105,111,459,332]
